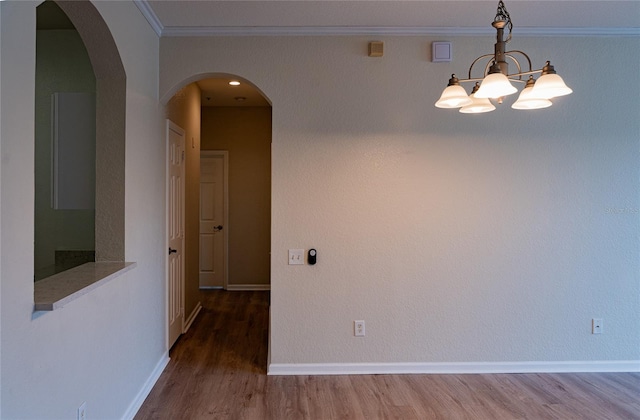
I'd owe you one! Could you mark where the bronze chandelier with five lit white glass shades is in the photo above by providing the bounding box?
[435,0,573,114]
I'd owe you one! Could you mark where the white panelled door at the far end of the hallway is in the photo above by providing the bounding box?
[200,151,228,289]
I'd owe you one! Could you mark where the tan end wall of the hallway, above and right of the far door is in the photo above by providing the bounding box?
[202,107,271,289]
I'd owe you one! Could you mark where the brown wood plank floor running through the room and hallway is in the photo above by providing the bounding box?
[136,291,640,420]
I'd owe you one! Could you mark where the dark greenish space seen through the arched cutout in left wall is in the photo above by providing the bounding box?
[34,1,96,282]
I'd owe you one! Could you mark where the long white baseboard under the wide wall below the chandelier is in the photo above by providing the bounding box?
[267,360,640,375]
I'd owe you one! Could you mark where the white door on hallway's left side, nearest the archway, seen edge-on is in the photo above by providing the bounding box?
[167,120,185,348]
